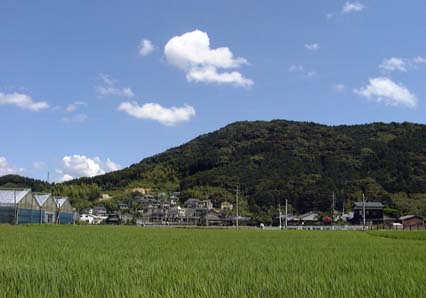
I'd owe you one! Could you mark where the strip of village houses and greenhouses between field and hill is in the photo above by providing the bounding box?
[0,189,425,230]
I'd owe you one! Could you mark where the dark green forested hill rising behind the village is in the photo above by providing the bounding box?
[0,120,426,219]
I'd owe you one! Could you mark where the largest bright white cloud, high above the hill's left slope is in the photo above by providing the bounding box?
[164,30,253,87]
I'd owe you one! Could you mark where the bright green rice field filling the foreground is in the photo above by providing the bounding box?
[0,226,426,297]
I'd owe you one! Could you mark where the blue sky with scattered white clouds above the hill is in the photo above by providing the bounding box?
[0,0,426,182]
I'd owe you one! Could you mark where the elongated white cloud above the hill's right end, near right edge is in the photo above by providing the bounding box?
[354,77,417,108]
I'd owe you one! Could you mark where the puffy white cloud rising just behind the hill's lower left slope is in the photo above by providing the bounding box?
[57,154,121,181]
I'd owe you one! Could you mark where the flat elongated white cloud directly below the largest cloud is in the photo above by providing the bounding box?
[118,102,195,126]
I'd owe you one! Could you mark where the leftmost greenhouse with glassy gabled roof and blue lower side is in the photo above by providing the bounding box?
[0,189,40,224]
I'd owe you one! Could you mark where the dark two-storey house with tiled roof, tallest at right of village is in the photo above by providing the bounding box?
[352,202,384,225]
